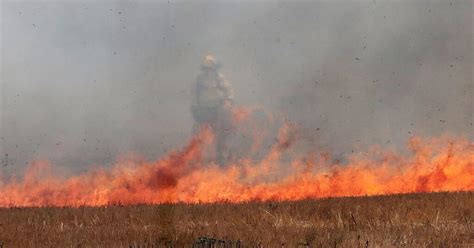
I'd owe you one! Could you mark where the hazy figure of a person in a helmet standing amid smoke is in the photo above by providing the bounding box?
[191,55,233,165]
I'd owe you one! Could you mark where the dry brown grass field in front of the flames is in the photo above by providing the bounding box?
[0,192,474,247]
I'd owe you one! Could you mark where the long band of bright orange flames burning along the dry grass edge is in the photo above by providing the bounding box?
[0,121,474,207]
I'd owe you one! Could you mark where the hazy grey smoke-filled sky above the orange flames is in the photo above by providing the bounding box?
[0,0,474,174]
